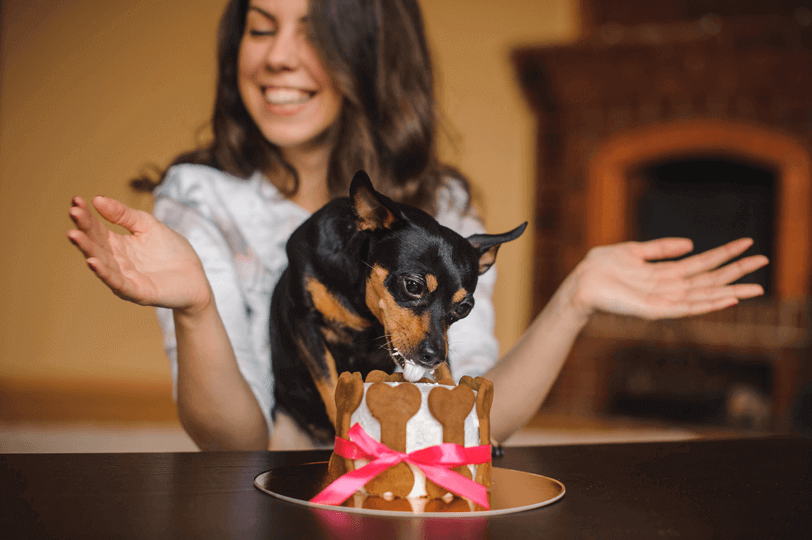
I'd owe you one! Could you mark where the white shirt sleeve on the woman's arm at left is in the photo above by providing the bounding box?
[153,169,273,429]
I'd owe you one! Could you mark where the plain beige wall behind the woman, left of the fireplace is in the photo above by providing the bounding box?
[0,0,577,404]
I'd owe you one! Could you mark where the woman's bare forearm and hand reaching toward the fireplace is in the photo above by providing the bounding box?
[485,238,767,441]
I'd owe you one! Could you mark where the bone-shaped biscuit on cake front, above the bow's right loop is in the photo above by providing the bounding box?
[426,385,476,499]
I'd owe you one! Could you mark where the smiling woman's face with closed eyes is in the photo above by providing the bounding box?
[237,0,342,152]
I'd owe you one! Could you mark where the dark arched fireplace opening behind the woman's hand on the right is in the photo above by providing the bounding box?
[630,156,777,295]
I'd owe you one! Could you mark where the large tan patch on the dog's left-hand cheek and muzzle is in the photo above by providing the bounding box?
[366,265,431,357]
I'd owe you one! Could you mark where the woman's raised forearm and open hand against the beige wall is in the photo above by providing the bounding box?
[68,197,268,450]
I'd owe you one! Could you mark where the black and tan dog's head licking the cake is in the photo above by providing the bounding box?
[350,171,527,379]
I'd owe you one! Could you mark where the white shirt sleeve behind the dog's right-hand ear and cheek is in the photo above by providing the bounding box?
[437,179,499,381]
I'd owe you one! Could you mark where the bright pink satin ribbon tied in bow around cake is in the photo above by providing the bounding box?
[310,424,491,510]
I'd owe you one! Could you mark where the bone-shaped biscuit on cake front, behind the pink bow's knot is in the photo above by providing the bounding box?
[365,382,423,498]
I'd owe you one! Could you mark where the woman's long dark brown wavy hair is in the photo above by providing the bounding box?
[131,0,470,213]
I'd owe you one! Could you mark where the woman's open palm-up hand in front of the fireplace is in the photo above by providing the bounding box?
[567,238,768,319]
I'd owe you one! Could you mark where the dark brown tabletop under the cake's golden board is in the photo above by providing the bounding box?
[0,438,812,540]
